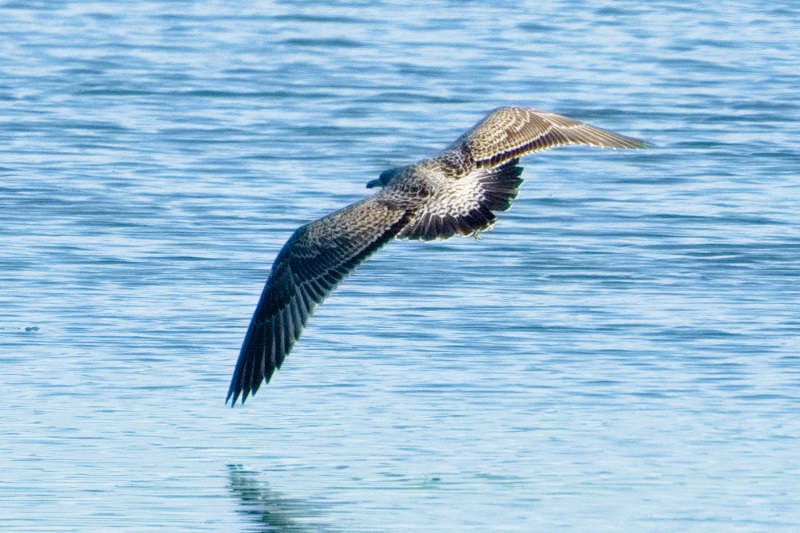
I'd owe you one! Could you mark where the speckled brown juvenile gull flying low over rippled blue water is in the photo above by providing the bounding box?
[225,107,646,405]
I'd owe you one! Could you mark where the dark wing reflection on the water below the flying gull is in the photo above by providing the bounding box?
[228,465,326,533]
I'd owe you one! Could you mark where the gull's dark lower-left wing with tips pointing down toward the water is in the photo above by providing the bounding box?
[226,194,409,405]
